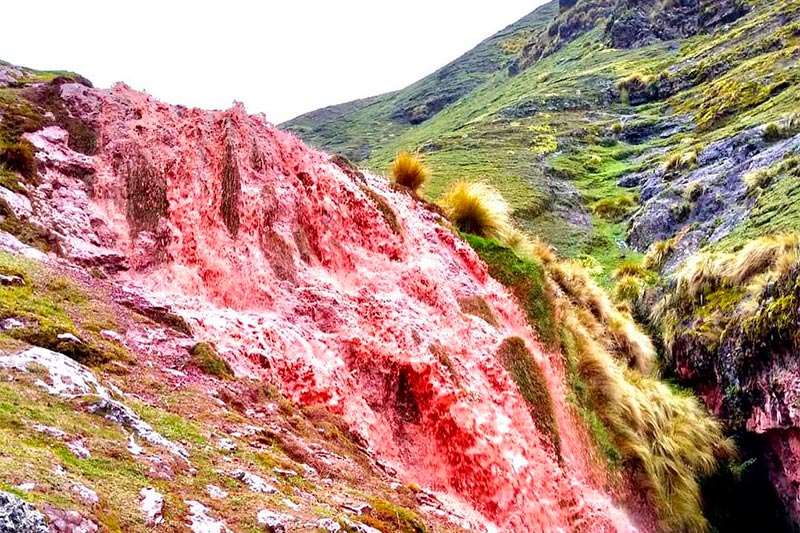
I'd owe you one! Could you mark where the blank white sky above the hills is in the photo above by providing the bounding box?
[0,0,544,123]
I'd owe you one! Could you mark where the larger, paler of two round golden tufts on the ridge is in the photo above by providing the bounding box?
[441,181,512,241]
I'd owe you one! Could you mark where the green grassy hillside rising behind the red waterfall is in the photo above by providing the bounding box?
[286,0,800,283]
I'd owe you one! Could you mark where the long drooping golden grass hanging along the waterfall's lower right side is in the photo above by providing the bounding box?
[485,234,735,531]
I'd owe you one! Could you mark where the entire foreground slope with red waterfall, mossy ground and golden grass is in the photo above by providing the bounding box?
[0,55,752,533]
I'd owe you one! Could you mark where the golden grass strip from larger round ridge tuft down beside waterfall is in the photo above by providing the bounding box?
[450,183,735,533]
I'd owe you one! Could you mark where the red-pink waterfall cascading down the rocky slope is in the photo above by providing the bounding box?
[0,82,635,532]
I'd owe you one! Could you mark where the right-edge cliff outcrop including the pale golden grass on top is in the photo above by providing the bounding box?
[662,256,800,530]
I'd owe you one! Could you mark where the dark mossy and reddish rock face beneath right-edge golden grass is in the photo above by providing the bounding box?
[670,268,800,525]
